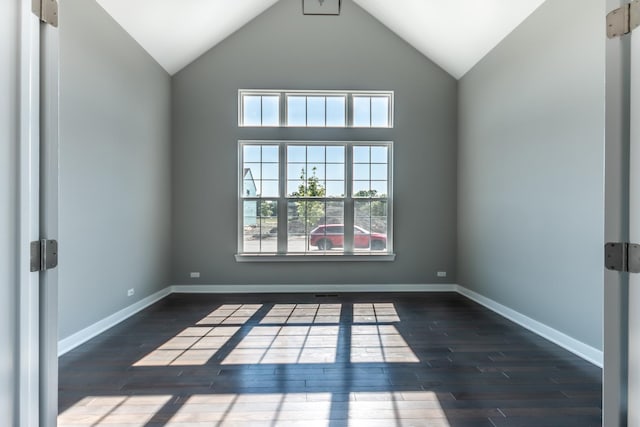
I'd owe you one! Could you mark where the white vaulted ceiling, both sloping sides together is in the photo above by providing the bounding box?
[97,0,545,78]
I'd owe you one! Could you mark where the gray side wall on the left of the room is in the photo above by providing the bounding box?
[59,0,171,338]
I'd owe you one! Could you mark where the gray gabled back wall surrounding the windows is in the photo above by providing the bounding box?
[172,0,457,284]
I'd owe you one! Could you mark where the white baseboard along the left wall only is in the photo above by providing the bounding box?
[58,287,172,357]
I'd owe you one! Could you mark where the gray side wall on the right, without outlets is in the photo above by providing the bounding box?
[458,0,605,349]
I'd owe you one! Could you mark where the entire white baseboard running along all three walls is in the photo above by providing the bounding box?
[58,284,603,367]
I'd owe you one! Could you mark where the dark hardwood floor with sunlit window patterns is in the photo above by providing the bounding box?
[58,293,602,427]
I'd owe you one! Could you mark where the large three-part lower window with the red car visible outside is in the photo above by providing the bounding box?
[238,141,393,256]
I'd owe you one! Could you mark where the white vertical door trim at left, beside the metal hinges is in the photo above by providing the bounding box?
[16,0,40,427]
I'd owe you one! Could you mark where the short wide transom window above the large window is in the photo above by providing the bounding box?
[238,90,393,128]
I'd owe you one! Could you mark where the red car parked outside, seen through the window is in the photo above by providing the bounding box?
[309,224,387,250]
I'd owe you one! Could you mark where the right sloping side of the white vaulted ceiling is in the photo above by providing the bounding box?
[354,0,545,79]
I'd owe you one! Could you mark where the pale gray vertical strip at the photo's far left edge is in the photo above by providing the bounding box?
[0,1,19,426]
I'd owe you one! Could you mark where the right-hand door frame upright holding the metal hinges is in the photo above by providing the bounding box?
[602,0,631,426]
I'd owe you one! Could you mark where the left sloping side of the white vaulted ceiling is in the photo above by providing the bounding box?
[97,0,278,75]
